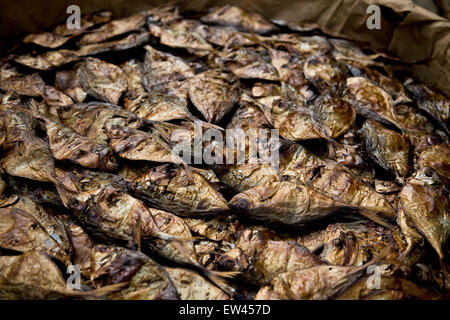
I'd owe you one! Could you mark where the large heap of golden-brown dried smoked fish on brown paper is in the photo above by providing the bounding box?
[0,5,450,299]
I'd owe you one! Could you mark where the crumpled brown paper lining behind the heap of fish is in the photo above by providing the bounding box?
[0,0,450,96]
